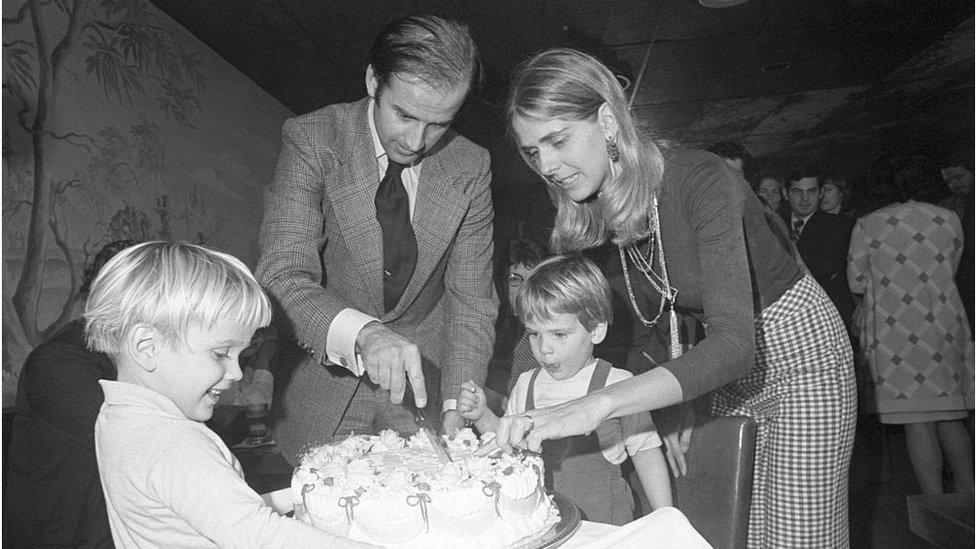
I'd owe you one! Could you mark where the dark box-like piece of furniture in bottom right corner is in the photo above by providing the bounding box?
[906,494,974,548]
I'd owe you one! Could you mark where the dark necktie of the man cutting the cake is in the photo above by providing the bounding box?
[376,160,417,311]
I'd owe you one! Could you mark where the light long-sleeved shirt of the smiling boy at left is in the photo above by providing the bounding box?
[95,380,362,548]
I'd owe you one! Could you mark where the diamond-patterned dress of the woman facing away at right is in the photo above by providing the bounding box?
[847,201,973,423]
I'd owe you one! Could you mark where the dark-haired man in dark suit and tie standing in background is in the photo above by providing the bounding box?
[783,168,854,330]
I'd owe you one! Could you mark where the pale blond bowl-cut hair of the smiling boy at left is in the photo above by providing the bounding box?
[85,241,271,354]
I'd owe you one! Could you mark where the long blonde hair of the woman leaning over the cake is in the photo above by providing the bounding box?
[506,48,664,253]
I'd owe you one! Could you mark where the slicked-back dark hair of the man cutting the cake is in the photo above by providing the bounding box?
[369,15,482,94]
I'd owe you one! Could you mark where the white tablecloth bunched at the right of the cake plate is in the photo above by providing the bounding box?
[560,507,712,549]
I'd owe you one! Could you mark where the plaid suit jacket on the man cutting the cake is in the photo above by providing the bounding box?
[257,98,498,459]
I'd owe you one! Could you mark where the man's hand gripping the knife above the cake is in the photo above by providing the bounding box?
[356,322,427,408]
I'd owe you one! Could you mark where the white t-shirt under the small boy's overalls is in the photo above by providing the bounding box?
[505,360,661,465]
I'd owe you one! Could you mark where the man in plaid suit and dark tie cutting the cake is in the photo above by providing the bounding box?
[257,16,498,463]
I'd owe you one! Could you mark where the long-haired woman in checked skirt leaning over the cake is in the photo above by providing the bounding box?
[496,49,855,548]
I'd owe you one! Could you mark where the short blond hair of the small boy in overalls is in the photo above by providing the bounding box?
[515,255,613,332]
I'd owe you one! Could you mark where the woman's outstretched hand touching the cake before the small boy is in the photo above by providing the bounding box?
[495,394,609,452]
